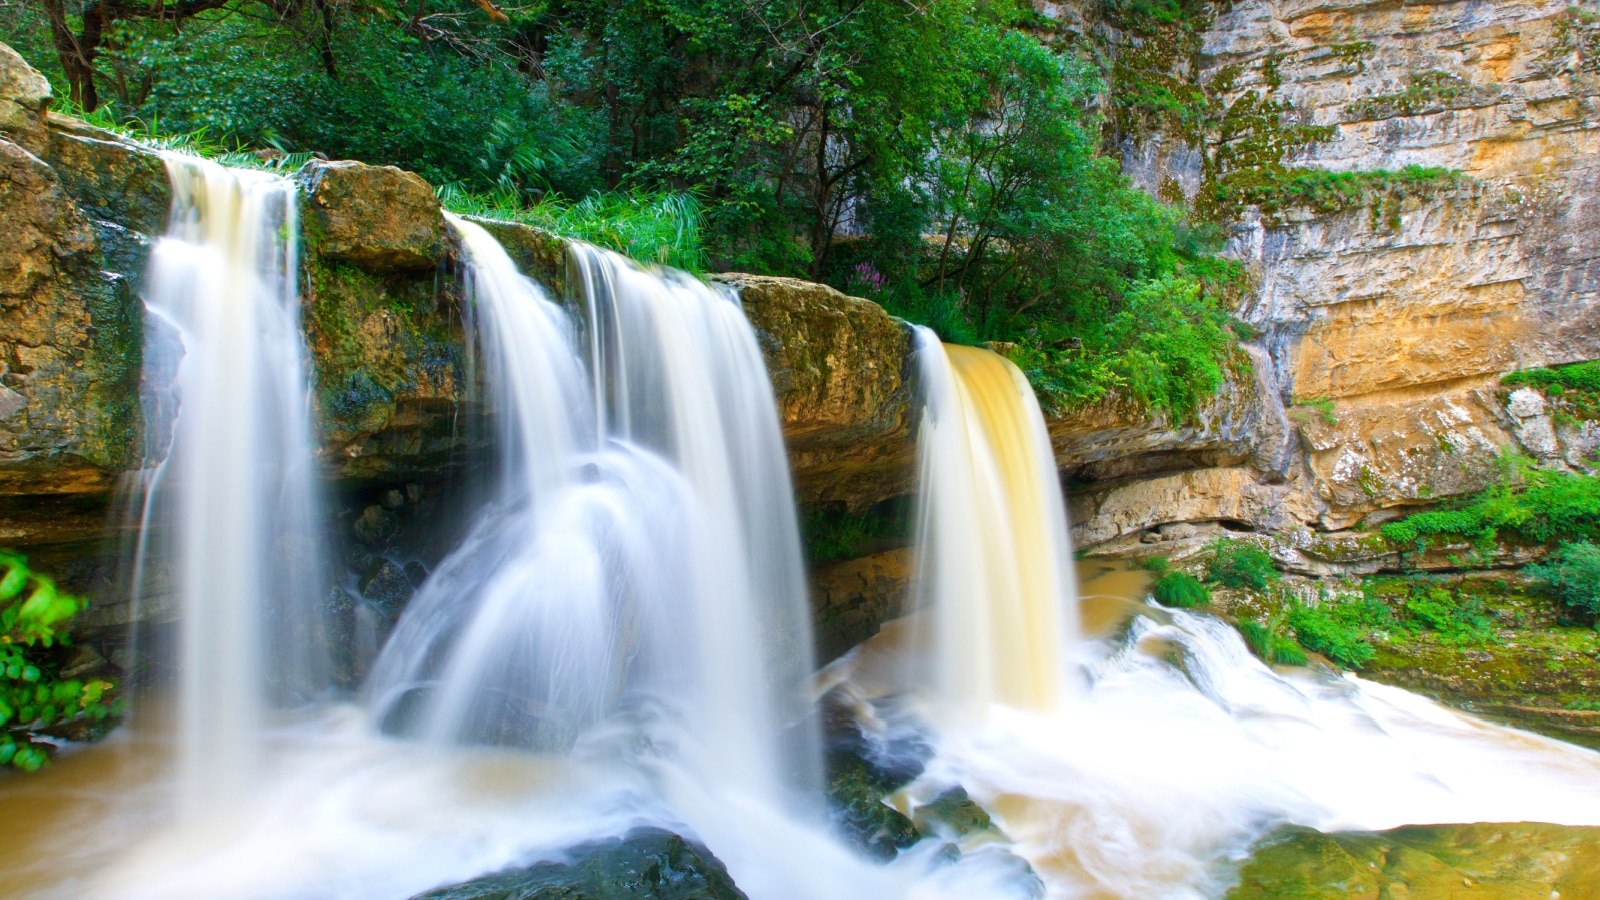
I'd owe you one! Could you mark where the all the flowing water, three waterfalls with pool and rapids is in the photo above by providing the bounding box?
[0,159,1600,900]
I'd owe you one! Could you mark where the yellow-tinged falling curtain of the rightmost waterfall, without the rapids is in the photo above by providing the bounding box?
[914,327,1078,721]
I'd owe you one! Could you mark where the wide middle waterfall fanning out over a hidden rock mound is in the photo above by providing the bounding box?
[373,218,818,799]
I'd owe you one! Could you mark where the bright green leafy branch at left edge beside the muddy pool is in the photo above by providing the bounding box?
[0,551,115,772]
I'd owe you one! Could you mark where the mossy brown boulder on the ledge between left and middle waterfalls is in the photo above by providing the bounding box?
[299,160,445,271]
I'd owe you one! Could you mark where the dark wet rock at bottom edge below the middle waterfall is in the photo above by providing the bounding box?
[414,828,746,900]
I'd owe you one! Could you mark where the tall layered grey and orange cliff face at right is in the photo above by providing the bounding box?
[1066,0,1600,543]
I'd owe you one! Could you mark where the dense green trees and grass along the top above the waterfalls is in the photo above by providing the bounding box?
[0,0,1248,415]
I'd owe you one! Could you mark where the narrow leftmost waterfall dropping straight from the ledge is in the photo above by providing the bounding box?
[138,154,326,814]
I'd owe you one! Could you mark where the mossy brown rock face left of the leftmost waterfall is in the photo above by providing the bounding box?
[0,54,147,546]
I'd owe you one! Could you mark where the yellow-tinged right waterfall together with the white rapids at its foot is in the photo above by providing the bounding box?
[822,330,1600,897]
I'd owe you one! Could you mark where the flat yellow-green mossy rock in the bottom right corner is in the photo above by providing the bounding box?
[1227,822,1600,900]
